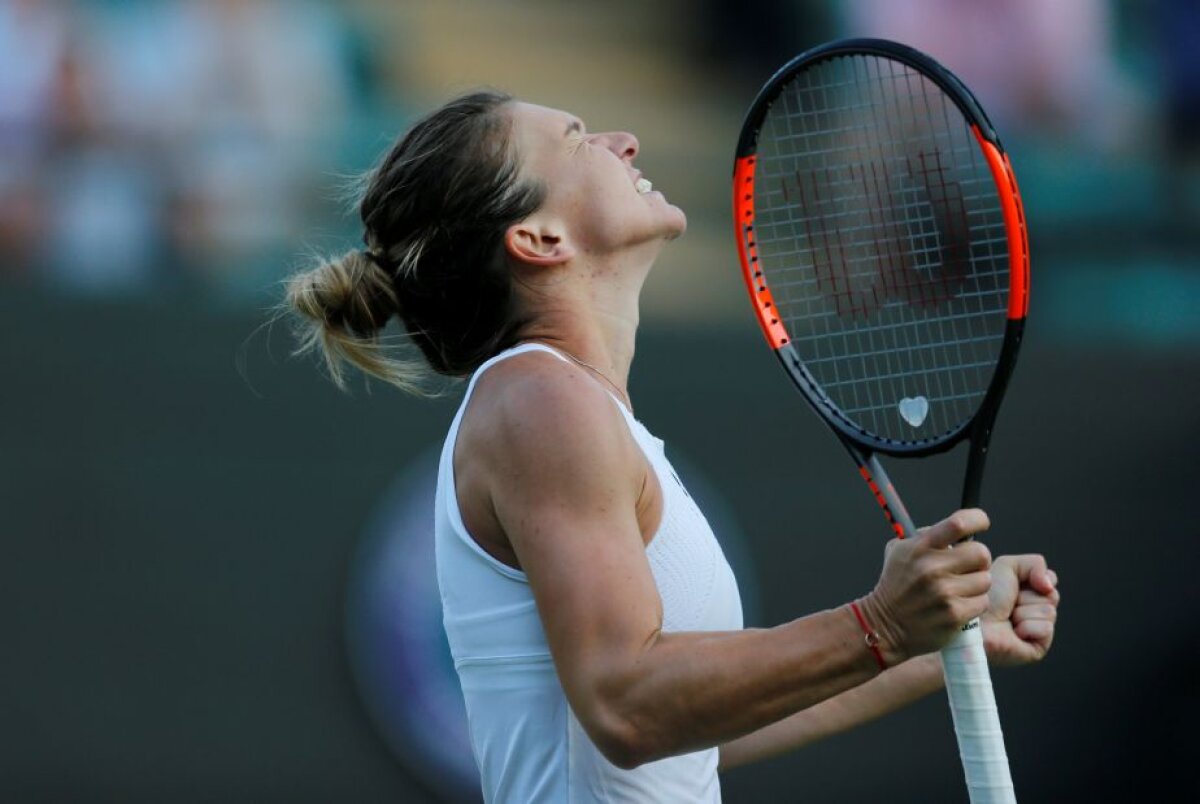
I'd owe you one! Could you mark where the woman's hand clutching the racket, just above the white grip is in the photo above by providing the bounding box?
[860,509,991,667]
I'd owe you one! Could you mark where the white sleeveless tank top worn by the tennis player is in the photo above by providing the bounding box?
[434,343,742,804]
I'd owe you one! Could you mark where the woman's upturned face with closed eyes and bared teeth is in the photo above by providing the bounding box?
[511,102,688,254]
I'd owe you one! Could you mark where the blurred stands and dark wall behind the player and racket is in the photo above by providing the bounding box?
[0,0,1200,802]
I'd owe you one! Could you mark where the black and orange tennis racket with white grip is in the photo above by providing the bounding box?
[733,40,1030,803]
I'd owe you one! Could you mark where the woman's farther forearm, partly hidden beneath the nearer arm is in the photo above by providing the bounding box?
[720,653,943,770]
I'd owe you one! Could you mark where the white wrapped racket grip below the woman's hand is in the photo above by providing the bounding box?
[942,618,1016,804]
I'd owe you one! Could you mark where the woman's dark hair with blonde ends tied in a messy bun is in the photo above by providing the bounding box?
[283,90,545,395]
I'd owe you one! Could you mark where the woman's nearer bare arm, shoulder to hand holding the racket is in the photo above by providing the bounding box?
[468,365,990,767]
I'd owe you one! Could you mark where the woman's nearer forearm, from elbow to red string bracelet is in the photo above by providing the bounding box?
[589,607,880,764]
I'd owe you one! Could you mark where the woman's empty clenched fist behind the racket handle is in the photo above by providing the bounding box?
[979,554,1058,666]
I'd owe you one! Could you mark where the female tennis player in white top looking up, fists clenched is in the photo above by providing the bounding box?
[288,91,1058,804]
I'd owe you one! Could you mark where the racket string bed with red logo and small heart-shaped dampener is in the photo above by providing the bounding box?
[754,55,1008,440]
